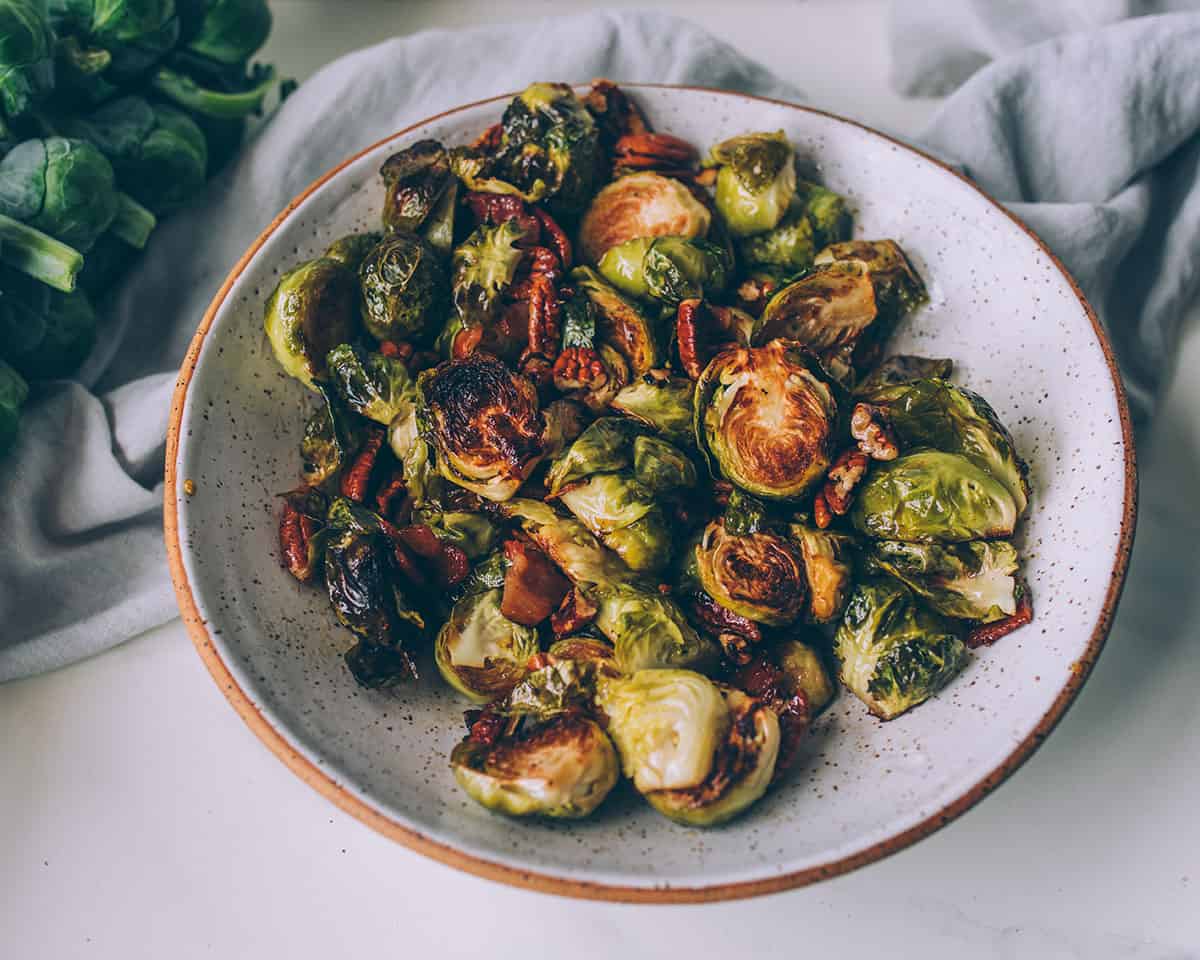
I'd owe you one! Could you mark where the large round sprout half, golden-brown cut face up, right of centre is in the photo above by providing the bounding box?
[694,340,839,500]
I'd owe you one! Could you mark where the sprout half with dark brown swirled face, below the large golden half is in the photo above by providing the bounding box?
[695,520,805,625]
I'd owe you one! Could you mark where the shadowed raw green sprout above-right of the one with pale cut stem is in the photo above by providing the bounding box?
[60,96,209,216]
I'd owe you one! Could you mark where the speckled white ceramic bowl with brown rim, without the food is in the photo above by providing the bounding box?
[166,86,1135,901]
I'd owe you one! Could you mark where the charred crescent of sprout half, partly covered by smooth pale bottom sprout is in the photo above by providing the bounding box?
[646,688,780,827]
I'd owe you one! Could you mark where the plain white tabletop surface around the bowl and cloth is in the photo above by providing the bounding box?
[0,0,1200,960]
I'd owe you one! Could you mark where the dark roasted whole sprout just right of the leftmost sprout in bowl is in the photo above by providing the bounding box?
[359,233,446,340]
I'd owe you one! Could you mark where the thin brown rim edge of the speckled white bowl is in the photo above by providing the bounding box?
[163,83,1138,904]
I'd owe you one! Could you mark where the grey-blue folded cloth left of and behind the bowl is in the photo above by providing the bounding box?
[0,12,799,680]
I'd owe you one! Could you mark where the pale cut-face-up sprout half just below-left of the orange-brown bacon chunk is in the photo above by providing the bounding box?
[433,589,538,703]
